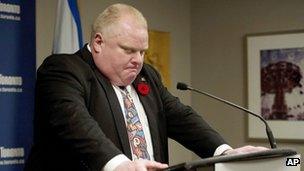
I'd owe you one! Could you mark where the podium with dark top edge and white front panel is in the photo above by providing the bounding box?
[165,149,300,171]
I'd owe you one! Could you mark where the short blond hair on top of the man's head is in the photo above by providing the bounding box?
[91,3,148,40]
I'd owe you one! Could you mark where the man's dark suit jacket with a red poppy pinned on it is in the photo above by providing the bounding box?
[25,47,225,171]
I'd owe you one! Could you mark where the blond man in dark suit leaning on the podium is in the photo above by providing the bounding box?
[26,4,268,171]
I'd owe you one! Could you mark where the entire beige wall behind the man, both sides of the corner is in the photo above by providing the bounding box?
[36,0,304,168]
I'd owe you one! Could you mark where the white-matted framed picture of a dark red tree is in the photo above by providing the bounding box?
[246,30,304,141]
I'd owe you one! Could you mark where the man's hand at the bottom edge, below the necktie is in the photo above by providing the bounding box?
[115,159,168,171]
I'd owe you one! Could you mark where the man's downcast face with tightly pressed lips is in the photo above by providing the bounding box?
[92,16,148,86]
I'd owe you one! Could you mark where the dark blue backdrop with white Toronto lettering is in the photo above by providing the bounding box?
[0,0,36,171]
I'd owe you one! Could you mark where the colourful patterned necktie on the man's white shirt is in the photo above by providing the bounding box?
[121,88,150,160]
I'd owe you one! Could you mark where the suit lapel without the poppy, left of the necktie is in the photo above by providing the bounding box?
[82,48,132,159]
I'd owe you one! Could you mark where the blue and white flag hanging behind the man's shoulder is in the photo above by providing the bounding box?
[53,0,82,53]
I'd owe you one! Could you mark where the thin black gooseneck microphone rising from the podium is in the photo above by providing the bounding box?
[176,82,277,149]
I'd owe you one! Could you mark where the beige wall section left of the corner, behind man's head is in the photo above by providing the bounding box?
[36,0,192,164]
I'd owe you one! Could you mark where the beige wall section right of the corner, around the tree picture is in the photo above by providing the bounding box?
[191,0,304,169]
